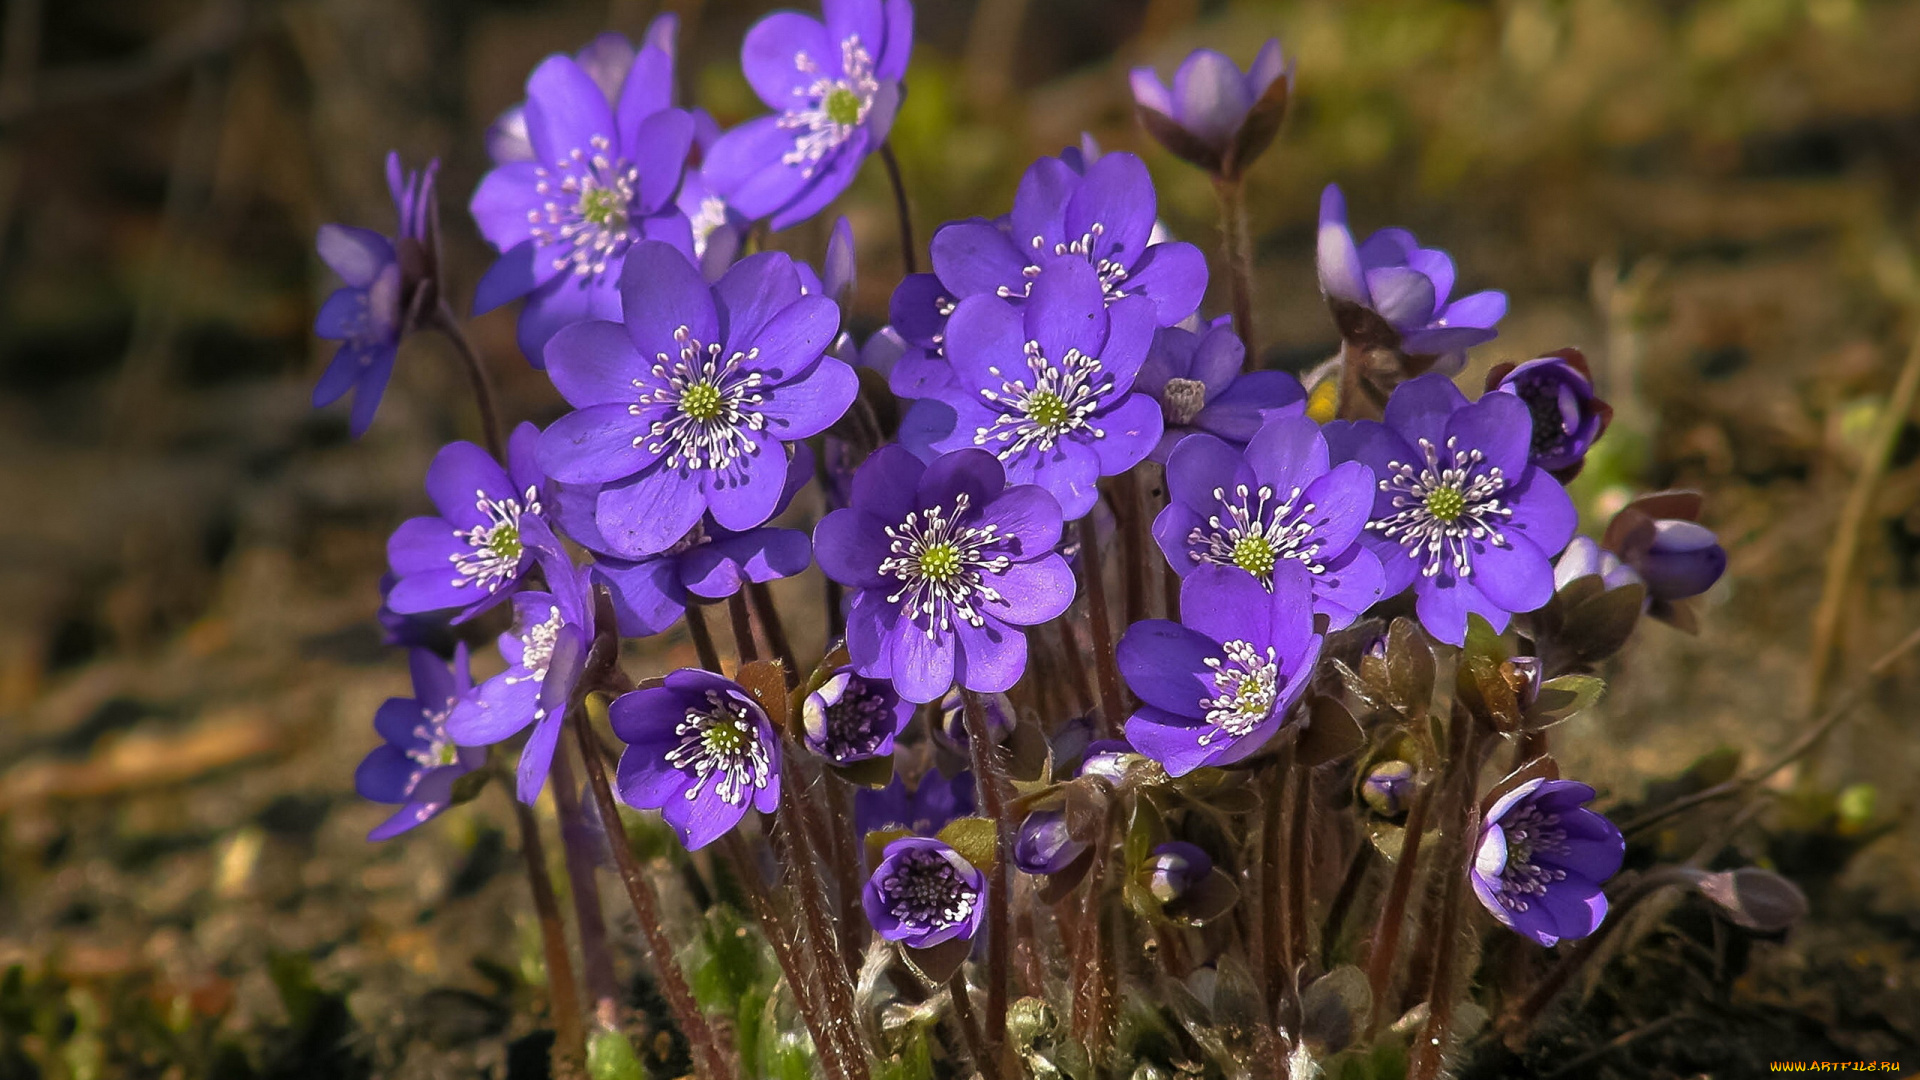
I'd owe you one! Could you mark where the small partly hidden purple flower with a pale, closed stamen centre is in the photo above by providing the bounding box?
[1133,315,1308,465]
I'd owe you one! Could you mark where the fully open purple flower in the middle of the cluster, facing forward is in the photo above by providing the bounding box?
[814,446,1073,701]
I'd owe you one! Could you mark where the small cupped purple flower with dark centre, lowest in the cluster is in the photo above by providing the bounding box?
[860,836,987,949]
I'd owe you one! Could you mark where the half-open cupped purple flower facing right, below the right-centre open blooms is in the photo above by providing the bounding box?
[1117,561,1321,776]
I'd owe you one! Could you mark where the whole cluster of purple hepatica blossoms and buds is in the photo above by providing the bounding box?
[315,0,1751,1045]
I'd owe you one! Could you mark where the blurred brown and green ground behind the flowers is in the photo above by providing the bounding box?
[0,0,1920,1080]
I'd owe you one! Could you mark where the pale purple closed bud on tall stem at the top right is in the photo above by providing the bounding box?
[1133,38,1294,181]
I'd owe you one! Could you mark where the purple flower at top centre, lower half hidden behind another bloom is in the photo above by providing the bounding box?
[931,154,1206,326]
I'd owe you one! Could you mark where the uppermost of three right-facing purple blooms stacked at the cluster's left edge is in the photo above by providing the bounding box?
[386,423,547,623]
